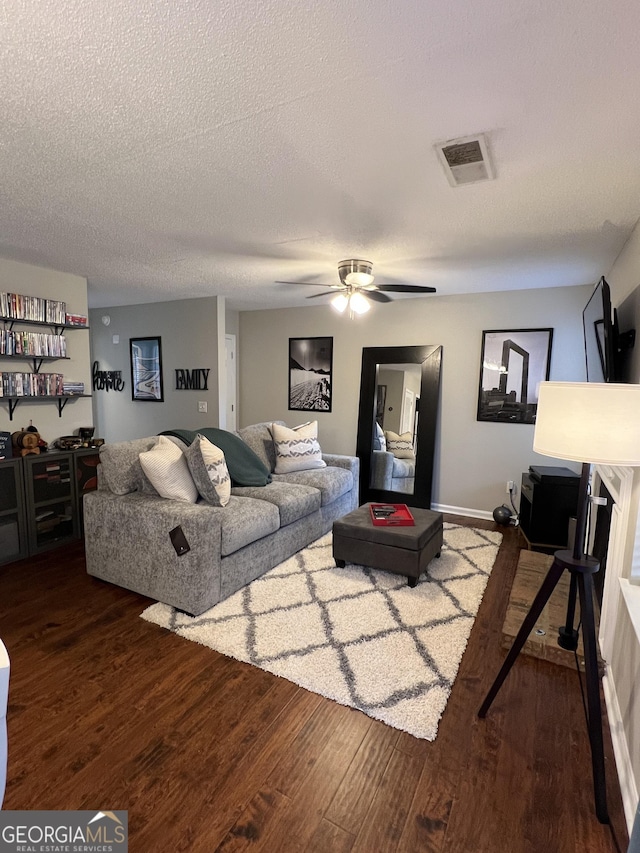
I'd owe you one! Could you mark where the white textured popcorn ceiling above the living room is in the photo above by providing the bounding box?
[0,0,640,309]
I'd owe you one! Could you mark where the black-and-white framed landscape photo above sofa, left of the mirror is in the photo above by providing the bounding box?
[289,338,333,412]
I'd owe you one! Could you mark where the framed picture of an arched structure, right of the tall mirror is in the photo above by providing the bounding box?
[478,329,553,424]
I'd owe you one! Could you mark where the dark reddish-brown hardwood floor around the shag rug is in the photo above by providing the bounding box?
[0,516,628,853]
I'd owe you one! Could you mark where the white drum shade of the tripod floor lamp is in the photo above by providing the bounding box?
[533,382,640,466]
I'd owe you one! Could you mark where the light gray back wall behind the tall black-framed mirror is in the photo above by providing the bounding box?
[240,285,592,514]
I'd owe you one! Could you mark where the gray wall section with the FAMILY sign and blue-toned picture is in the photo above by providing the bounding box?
[90,297,219,442]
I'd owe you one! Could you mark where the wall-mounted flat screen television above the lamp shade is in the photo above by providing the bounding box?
[582,276,619,382]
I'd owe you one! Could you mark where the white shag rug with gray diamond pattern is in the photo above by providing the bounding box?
[142,523,502,740]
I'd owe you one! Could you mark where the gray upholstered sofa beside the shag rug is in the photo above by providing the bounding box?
[84,422,359,615]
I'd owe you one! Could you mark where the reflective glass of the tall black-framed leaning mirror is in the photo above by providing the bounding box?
[370,364,422,495]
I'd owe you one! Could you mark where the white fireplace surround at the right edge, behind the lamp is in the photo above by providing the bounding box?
[594,465,640,833]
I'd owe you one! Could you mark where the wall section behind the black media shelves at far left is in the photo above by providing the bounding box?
[0,258,93,444]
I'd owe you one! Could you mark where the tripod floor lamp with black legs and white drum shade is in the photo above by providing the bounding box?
[478,382,640,823]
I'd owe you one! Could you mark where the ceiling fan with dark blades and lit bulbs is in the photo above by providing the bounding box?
[276,258,436,317]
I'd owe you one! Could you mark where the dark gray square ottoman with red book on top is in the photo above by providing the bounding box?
[333,504,442,587]
